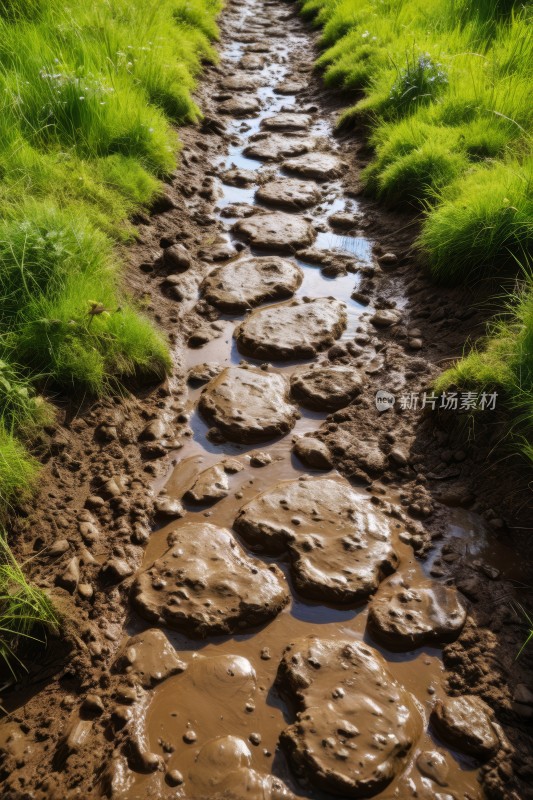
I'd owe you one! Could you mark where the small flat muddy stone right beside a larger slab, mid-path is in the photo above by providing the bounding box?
[291,364,363,411]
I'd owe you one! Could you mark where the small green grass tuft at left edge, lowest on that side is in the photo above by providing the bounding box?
[0,532,59,675]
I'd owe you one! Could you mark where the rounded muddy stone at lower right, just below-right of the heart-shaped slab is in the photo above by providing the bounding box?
[368,571,466,650]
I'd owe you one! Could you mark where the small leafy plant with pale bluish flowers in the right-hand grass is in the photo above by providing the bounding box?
[389,53,448,114]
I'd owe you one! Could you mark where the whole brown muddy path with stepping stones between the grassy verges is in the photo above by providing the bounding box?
[0,0,533,800]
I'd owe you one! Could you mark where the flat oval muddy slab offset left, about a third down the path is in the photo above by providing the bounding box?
[200,256,303,314]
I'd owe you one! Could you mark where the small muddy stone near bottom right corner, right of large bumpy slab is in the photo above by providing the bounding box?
[430,695,500,760]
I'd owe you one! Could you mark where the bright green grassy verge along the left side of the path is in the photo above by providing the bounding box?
[0,0,220,660]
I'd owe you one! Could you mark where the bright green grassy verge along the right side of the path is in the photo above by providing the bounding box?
[302,0,533,460]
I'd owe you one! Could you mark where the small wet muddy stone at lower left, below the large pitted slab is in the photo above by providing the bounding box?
[113,628,186,689]
